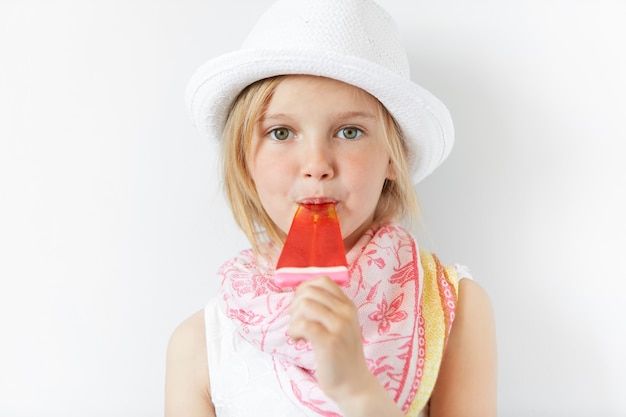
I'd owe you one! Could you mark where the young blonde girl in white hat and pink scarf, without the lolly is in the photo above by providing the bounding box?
[165,0,496,417]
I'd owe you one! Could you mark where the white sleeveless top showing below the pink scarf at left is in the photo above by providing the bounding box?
[204,298,428,417]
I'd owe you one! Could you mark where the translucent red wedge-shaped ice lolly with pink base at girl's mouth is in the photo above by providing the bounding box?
[274,203,349,287]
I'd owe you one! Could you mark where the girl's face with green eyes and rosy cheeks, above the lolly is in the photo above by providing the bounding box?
[247,75,395,249]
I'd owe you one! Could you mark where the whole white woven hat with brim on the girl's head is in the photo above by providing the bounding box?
[187,0,454,183]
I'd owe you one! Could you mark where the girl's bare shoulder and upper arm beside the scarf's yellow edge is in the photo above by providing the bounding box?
[431,279,497,416]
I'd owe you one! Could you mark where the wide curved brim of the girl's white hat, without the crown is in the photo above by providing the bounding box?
[187,49,454,183]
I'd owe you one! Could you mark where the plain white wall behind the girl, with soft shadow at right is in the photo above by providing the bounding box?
[0,0,626,417]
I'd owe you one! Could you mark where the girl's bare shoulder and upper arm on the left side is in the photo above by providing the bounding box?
[165,310,214,416]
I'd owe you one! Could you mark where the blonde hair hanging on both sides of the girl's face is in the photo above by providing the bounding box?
[221,75,420,250]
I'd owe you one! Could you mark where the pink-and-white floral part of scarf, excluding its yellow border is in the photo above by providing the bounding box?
[219,223,425,416]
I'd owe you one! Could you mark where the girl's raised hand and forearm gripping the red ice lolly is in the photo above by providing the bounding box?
[288,277,401,416]
